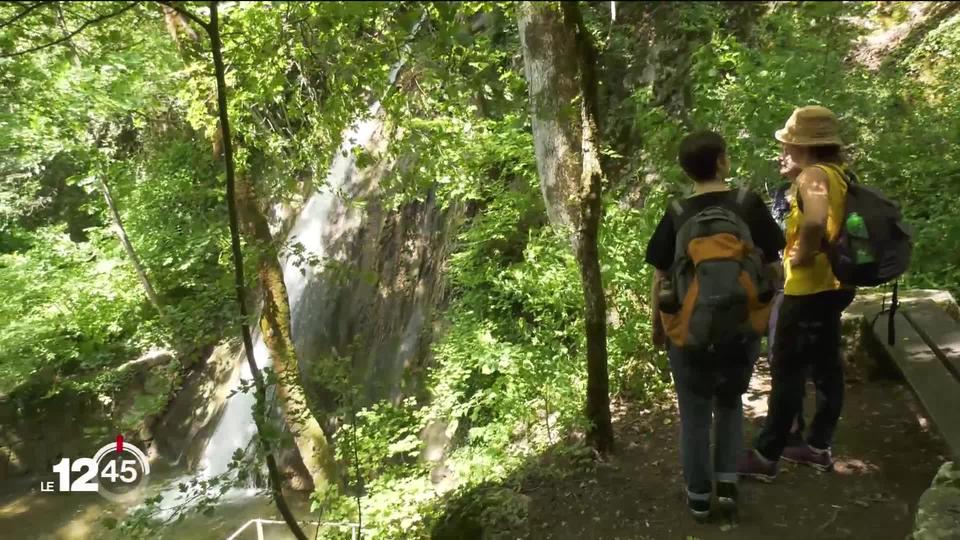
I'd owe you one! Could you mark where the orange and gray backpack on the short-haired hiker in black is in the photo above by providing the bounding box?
[660,188,773,351]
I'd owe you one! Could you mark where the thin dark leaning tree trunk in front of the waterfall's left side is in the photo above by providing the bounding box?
[207,0,307,540]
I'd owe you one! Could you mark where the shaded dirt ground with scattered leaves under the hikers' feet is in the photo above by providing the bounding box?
[521,358,945,540]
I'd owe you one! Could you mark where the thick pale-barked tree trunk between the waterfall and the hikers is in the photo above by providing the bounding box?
[519,2,613,453]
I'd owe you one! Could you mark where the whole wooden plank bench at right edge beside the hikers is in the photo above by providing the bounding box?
[873,300,960,459]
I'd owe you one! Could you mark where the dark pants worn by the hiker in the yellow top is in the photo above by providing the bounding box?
[755,290,854,461]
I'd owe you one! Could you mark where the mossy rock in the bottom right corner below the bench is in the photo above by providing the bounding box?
[912,461,960,540]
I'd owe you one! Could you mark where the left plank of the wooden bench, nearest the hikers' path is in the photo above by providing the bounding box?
[873,313,960,459]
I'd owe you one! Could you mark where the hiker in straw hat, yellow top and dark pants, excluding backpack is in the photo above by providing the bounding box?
[738,105,854,481]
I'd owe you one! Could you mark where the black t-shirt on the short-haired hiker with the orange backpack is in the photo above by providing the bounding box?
[646,190,786,272]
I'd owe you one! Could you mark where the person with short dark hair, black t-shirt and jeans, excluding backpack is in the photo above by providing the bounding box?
[646,131,785,519]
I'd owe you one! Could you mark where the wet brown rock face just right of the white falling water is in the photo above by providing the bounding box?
[282,130,462,412]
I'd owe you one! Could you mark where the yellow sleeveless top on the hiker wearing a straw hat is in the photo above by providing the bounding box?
[783,165,847,296]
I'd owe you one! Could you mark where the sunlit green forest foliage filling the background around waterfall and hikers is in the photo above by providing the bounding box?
[0,2,960,537]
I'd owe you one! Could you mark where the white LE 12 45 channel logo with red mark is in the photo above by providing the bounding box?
[40,435,150,502]
